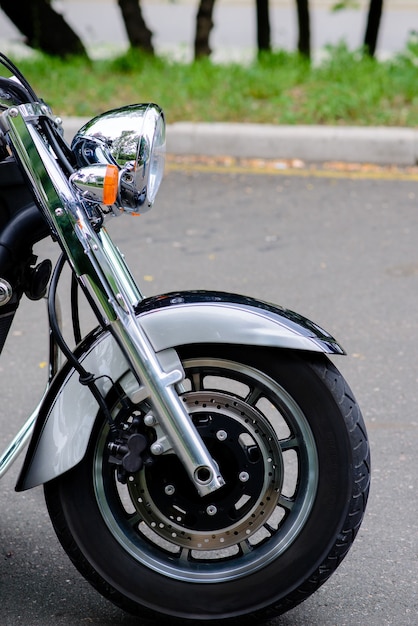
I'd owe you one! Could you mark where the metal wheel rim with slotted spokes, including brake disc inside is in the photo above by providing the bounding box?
[93,357,319,583]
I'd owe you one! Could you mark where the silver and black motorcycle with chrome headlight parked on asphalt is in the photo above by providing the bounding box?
[0,55,370,625]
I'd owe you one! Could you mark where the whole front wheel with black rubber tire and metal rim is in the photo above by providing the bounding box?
[45,345,370,626]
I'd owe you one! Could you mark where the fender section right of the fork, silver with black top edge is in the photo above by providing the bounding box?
[138,291,344,354]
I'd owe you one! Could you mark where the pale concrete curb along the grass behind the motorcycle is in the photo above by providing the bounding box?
[63,117,418,166]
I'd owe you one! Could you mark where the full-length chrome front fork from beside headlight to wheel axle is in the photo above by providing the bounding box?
[2,103,224,496]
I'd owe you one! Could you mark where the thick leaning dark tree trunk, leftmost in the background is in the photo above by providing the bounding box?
[0,0,87,57]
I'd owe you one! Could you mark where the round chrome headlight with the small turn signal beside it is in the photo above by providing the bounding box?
[71,104,165,213]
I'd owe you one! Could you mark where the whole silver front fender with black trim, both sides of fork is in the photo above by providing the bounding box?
[16,291,344,491]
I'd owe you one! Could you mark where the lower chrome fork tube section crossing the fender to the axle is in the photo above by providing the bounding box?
[81,223,225,496]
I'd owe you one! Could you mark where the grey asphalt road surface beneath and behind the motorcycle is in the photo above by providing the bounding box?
[0,163,418,626]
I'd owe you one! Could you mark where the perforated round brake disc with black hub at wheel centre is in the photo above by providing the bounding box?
[128,391,283,550]
